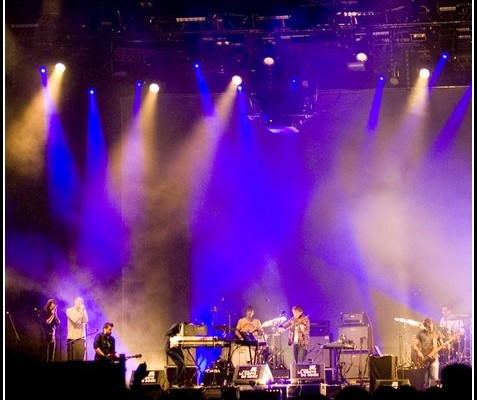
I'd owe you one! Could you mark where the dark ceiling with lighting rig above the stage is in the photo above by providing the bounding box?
[5,0,472,92]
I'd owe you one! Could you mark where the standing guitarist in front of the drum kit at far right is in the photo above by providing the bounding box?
[412,318,447,389]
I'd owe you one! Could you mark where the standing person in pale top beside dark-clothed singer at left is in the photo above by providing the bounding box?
[66,297,88,361]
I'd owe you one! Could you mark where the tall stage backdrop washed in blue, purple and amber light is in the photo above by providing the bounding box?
[5,88,472,376]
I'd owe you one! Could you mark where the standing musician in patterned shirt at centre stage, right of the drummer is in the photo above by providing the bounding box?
[279,305,310,363]
